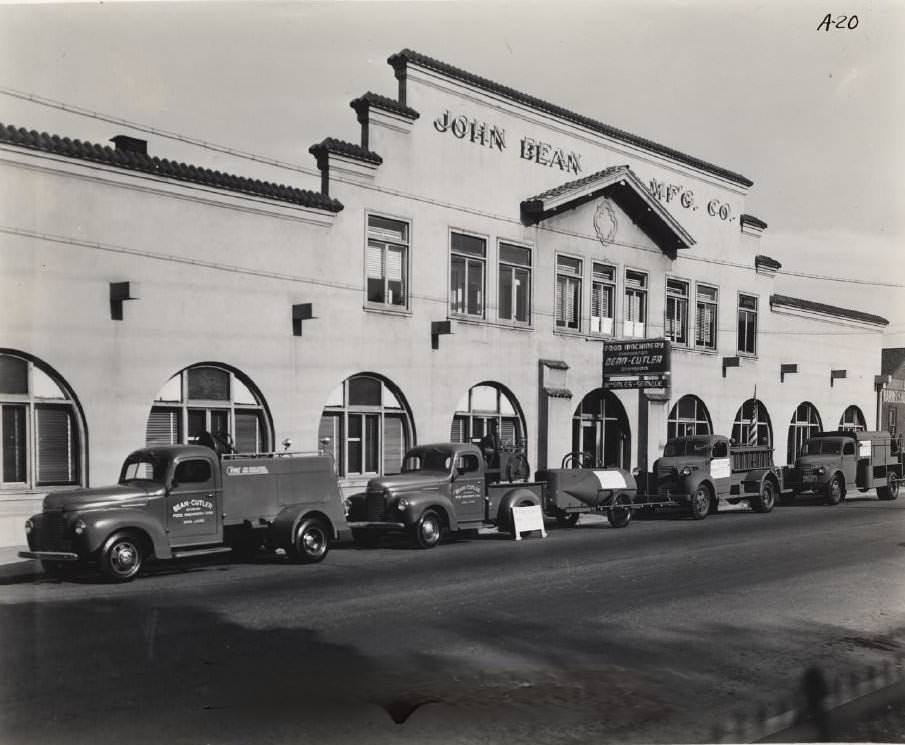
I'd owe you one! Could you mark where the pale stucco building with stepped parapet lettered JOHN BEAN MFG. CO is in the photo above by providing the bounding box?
[0,51,888,543]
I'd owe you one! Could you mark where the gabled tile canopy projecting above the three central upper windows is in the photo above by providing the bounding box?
[521,166,695,257]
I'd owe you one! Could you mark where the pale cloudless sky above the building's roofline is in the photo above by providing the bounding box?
[0,0,905,346]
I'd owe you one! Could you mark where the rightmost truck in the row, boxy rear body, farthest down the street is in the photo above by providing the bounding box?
[787,431,903,505]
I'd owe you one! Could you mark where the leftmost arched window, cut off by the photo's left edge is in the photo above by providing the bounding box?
[0,353,85,489]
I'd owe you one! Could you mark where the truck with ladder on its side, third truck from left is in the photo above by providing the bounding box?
[635,435,783,520]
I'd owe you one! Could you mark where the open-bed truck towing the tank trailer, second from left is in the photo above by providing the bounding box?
[346,442,543,548]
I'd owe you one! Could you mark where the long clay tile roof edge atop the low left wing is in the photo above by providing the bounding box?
[0,123,343,212]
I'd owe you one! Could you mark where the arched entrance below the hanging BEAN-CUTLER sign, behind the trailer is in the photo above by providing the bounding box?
[572,388,632,468]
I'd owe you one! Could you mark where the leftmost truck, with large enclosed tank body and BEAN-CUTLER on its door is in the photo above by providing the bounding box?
[19,438,349,581]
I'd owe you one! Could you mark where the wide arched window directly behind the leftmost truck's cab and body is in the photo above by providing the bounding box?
[145,364,273,453]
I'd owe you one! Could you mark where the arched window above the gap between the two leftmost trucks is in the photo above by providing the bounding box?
[318,374,412,477]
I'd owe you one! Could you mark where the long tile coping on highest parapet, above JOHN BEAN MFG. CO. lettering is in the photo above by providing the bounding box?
[387,49,754,186]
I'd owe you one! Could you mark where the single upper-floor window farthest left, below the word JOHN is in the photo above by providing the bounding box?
[365,215,409,308]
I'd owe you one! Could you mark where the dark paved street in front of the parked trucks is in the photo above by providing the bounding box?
[0,495,905,743]
